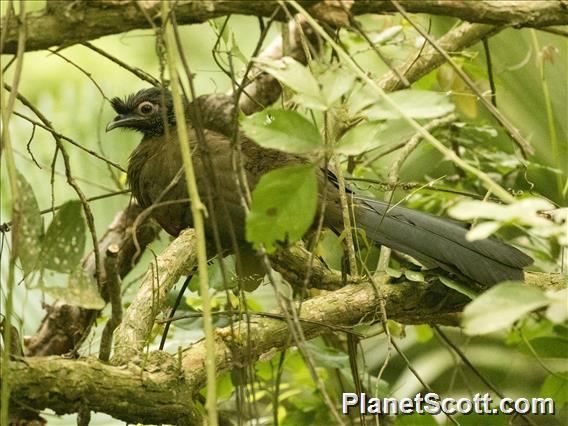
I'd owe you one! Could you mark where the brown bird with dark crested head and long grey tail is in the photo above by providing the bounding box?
[106,87,533,287]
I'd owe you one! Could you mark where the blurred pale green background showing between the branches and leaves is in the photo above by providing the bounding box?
[0,1,568,424]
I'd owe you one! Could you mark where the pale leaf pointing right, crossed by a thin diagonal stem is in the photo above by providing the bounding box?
[366,89,455,120]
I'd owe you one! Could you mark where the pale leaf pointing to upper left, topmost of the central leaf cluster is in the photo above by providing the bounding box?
[255,56,327,110]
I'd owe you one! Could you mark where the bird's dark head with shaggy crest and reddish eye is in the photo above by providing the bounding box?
[106,87,176,136]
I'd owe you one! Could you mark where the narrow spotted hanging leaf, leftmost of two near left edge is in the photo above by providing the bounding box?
[13,173,43,275]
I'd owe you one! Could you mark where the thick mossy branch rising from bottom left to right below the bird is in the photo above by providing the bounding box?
[8,270,566,424]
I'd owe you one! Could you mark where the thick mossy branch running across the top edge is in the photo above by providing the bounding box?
[2,0,568,53]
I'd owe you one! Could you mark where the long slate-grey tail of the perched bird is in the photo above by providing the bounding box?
[346,199,533,285]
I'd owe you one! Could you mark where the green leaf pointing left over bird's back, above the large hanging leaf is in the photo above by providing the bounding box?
[241,108,323,154]
